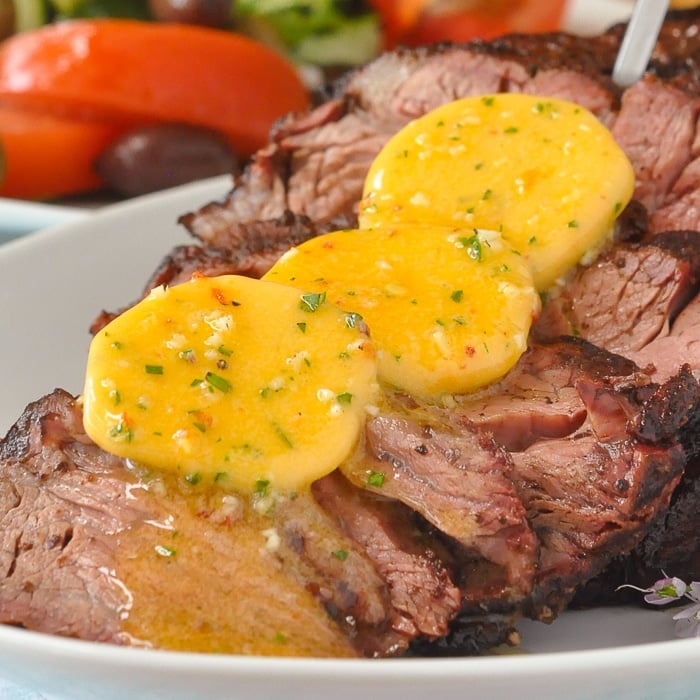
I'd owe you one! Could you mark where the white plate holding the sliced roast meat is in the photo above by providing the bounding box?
[0,167,700,700]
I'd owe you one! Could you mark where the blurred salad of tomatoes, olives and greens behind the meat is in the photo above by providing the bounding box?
[0,0,565,201]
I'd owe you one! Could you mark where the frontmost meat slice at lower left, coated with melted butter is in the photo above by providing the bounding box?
[0,390,428,656]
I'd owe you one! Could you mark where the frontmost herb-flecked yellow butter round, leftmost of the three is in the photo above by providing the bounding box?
[83,276,377,493]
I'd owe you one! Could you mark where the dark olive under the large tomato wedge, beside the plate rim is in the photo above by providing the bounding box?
[95,124,238,197]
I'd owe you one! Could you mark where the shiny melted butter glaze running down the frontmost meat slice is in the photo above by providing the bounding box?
[114,477,356,657]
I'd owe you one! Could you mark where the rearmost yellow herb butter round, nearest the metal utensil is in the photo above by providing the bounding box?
[360,93,634,290]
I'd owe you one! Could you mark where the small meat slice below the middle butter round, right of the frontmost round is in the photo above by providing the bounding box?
[341,415,538,601]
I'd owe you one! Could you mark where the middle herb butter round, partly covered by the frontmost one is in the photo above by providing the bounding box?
[266,225,540,397]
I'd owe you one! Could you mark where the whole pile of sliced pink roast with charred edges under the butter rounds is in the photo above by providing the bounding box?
[0,11,700,657]
